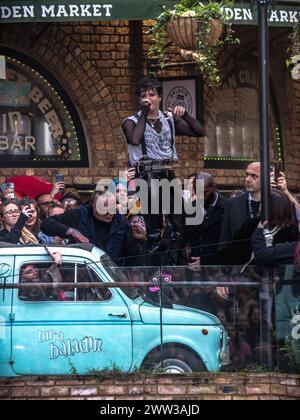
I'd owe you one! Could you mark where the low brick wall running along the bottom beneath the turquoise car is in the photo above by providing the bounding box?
[0,373,300,400]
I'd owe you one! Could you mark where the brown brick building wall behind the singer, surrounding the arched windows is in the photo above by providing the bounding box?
[0,21,300,187]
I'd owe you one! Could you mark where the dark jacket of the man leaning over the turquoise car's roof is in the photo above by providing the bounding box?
[41,206,144,266]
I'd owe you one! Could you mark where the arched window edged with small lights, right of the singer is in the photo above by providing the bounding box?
[205,56,283,168]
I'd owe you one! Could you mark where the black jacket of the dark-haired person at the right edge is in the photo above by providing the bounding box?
[252,229,297,267]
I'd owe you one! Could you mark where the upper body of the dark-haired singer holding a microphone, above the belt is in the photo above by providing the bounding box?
[122,77,205,166]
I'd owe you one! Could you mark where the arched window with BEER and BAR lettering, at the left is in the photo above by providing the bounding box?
[0,49,87,167]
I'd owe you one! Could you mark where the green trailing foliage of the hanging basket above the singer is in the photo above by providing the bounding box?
[148,0,239,86]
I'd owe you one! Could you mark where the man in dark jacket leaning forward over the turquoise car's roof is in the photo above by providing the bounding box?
[41,188,146,266]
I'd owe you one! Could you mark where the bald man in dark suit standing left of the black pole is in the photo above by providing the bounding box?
[219,162,261,264]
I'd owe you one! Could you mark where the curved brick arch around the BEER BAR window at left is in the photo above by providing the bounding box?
[0,24,127,183]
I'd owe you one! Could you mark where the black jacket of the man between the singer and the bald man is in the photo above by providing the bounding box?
[185,194,228,265]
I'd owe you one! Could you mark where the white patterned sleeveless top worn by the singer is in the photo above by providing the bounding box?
[125,111,178,165]
